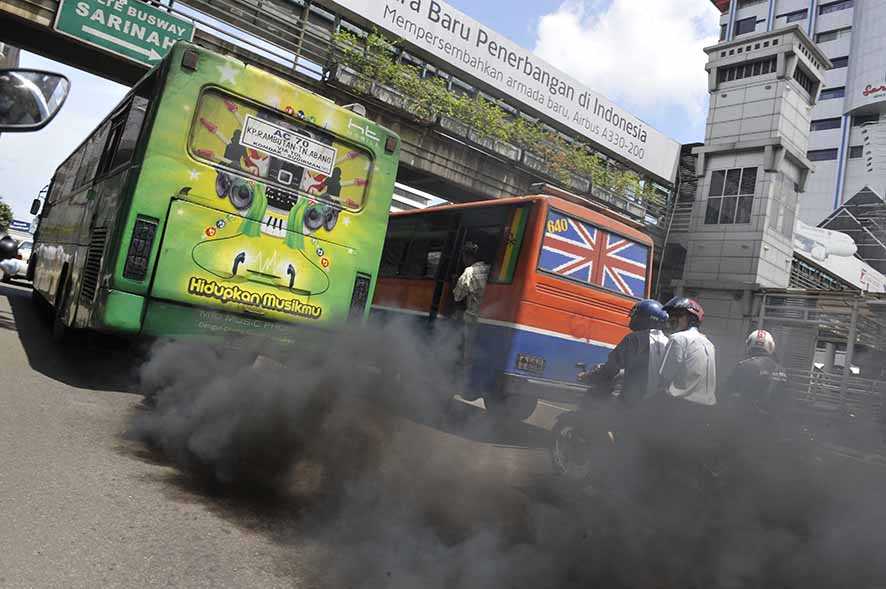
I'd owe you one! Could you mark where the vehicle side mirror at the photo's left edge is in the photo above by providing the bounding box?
[0,69,71,133]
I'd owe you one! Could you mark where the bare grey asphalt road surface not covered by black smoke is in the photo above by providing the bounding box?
[0,284,560,587]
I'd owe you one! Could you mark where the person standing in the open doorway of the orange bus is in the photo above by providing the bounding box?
[452,241,490,396]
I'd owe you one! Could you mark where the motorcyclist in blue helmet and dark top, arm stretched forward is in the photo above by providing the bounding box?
[582,299,668,402]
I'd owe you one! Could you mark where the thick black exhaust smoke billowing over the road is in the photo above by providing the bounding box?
[125,323,886,589]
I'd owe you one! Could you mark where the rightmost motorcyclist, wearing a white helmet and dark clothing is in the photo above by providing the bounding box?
[726,329,787,415]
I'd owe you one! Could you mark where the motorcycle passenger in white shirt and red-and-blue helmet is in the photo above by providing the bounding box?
[659,297,717,406]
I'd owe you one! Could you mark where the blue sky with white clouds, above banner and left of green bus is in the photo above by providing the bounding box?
[0,0,719,220]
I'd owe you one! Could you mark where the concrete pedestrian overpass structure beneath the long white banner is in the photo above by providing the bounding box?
[0,0,669,241]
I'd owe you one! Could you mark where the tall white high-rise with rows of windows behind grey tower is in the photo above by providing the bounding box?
[712,0,886,226]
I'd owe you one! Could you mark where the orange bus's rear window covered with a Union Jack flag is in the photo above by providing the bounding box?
[538,209,649,298]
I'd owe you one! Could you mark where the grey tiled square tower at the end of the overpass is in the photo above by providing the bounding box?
[666,26,831,365]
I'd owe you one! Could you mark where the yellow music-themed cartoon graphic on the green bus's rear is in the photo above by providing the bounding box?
[184,90,371,294]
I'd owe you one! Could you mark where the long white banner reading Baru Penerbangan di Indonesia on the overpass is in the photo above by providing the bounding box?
[327,0,680,182]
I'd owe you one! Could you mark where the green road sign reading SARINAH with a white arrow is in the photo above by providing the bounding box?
[54,0,194,66]
